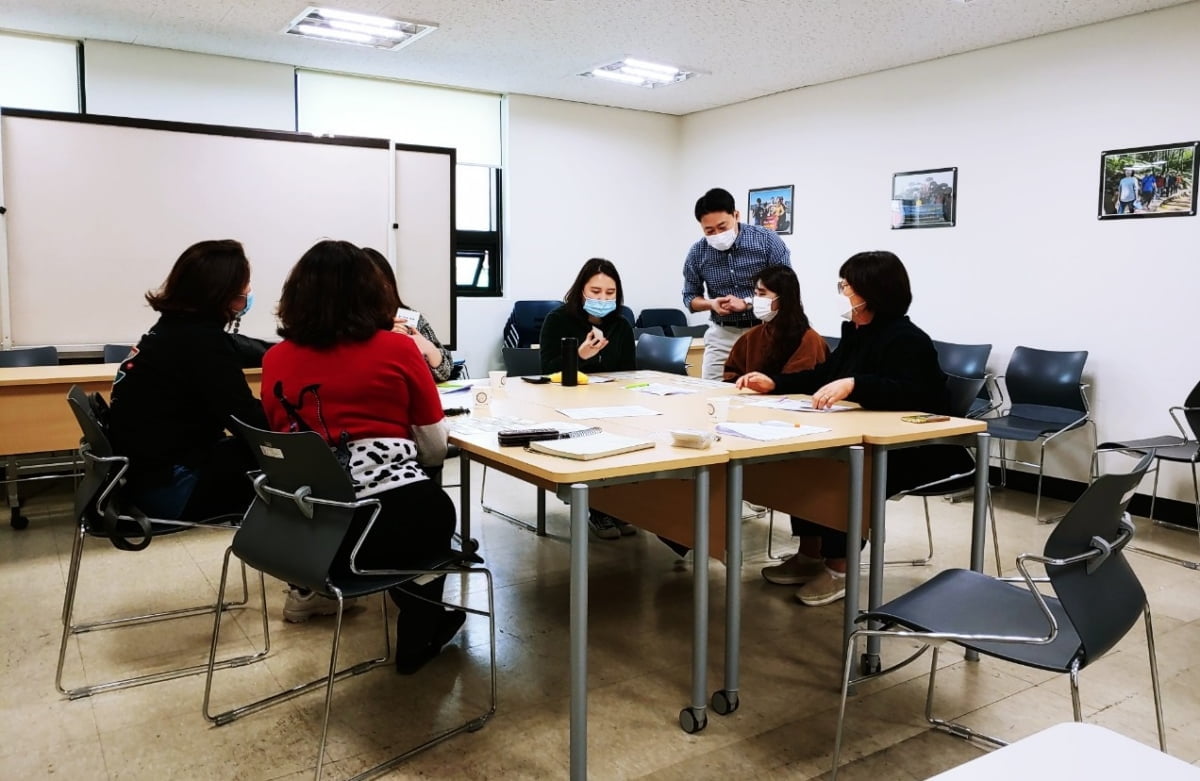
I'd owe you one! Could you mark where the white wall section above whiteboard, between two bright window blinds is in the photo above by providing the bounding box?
[84,41,295,131]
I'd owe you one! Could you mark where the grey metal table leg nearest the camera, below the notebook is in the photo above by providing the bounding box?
[570,483,588,781]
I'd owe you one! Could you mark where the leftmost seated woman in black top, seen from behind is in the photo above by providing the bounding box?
[109,239,266,521]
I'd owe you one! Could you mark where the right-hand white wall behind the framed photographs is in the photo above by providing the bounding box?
[680,2,1200,501]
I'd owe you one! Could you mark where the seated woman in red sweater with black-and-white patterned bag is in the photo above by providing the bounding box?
[263,241,466,674]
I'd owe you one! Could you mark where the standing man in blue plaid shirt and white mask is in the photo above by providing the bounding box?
[683,187,792,380]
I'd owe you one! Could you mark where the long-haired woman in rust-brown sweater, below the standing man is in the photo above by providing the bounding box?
[724,266,829,383]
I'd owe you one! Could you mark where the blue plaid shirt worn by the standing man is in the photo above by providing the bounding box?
[683,223,792,326]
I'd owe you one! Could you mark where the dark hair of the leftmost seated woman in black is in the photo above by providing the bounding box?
[146,239,250,323]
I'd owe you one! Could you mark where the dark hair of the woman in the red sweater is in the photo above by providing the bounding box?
[278,240,396,348]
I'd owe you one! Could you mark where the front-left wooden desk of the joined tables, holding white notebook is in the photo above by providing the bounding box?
[450,382,727,781]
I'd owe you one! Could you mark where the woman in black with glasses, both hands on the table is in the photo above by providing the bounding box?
[737,252,970,606]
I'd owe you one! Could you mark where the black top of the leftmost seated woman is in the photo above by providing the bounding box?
[109,313,268,486]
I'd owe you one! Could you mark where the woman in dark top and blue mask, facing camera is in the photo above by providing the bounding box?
[539,258,636,374]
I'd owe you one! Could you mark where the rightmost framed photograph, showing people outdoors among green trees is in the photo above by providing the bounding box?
[1097,142,1200,220]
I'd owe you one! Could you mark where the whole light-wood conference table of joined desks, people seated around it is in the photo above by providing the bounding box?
[450,371,988,779]
